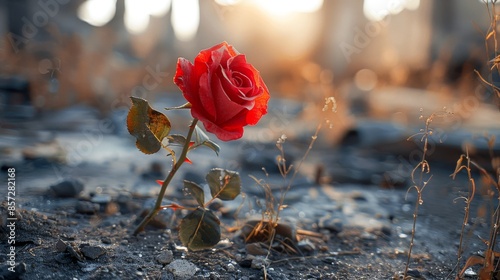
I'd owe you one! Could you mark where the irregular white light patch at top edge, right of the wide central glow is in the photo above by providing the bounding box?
[363,0,420,21]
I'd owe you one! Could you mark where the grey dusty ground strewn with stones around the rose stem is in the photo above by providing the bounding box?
[0,97,500,279]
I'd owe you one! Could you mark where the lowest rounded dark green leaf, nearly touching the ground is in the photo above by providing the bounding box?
[179,207,220,251]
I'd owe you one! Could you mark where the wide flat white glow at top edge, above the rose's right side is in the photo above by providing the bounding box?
[255,0,323,15]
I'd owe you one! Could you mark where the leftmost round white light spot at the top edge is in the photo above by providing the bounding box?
[77,0,116,26]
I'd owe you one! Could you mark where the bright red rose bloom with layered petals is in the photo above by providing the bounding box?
[174,42,269,141]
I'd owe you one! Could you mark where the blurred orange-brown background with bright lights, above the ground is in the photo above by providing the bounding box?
[0,0,494,115]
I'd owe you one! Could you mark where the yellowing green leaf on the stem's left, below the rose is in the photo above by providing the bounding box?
[127,96,172,154]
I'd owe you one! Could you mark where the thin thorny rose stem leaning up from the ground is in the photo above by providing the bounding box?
[134,118,198,235]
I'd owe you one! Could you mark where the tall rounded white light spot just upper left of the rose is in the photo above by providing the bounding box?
[172,0,200,41]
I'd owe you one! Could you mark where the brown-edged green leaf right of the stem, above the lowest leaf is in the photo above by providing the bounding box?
[206,168,241,200]
